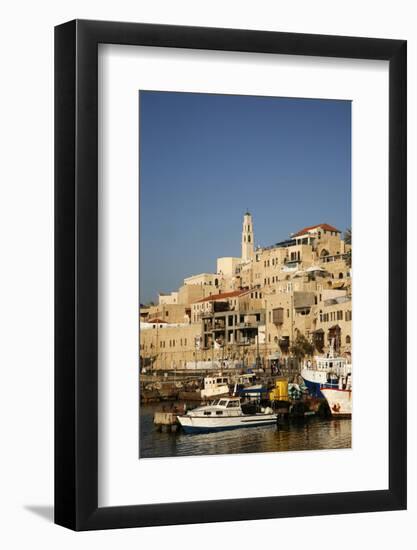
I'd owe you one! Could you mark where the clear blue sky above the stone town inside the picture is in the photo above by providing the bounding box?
[139,91,351,303]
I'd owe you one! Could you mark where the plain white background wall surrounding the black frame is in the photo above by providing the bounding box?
[0,0,417,550]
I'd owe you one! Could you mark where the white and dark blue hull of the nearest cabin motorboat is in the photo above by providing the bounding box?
[177,414,277,433]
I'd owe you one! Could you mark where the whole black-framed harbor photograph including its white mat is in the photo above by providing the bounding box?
[55,20,407,530]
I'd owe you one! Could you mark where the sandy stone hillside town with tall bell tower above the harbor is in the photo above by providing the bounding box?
[140,212,352,372]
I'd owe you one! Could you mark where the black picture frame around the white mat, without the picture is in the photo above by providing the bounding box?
[55,20,407,530]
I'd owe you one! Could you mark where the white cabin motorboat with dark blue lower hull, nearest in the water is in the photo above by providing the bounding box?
[177,397,277,433]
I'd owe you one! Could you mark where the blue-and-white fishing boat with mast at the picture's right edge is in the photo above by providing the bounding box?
[301,338,352,398]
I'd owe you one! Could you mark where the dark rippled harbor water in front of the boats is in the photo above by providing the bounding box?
[139,404,352,458]
